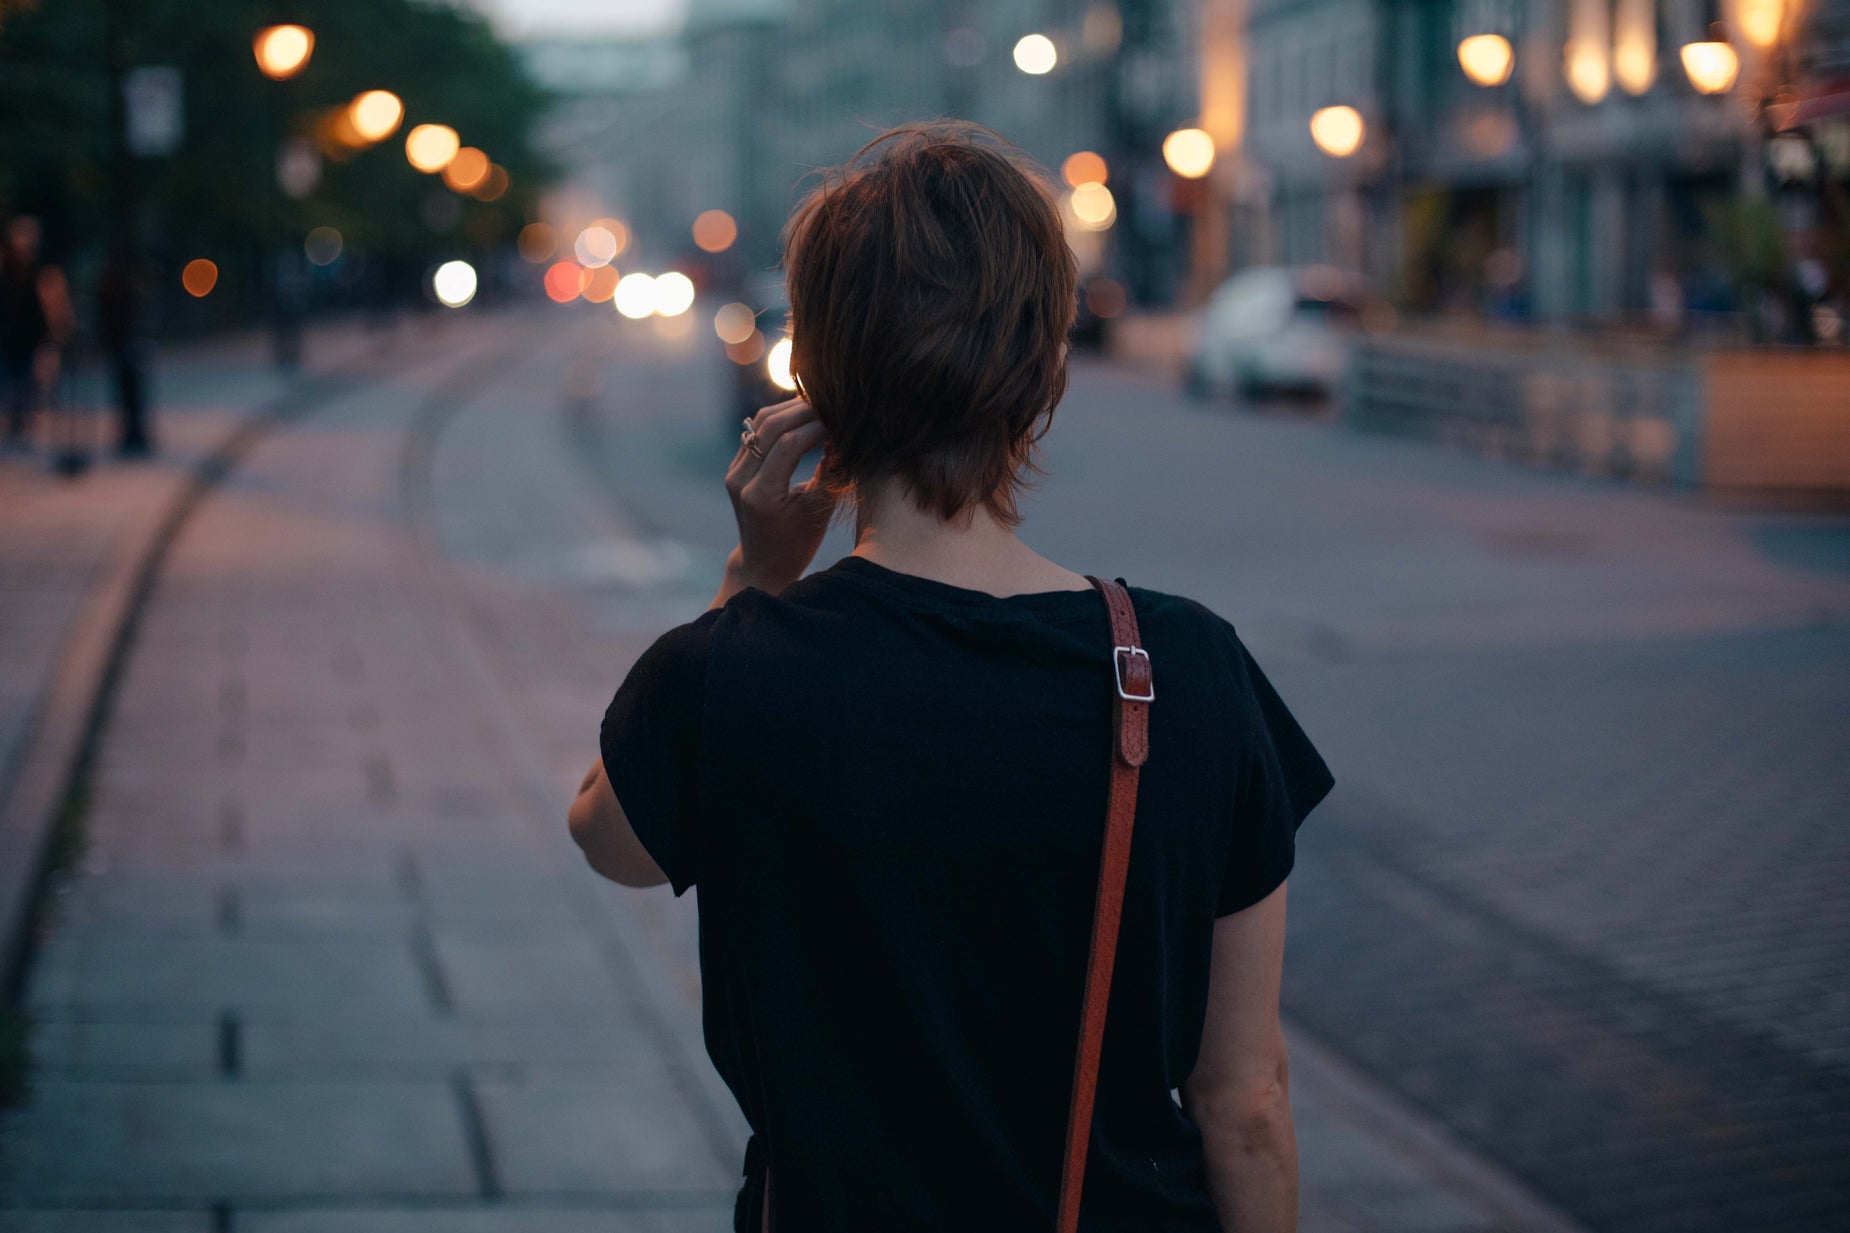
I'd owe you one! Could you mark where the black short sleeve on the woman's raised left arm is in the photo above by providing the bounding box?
[599,609,720,896]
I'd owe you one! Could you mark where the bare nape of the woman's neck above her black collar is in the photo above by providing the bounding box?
[853,485,1092,596]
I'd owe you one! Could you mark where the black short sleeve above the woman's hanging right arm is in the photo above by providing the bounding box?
[1214,626,1336,916]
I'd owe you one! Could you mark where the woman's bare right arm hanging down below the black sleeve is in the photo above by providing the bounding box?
[1182,883,1297,1233]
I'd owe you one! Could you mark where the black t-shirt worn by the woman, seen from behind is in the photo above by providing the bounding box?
[603,557,1332,1233]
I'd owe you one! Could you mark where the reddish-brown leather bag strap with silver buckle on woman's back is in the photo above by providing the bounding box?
[1058,574,1156,1233]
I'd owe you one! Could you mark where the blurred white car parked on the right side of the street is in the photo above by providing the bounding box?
[1188,267,1360,398]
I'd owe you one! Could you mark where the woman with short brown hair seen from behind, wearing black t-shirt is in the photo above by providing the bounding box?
[570,124,1330,1233]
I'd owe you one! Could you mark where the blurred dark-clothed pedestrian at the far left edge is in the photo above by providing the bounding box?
[0,215,74,446]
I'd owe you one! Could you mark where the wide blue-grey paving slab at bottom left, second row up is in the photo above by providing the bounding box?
[0,1079,479,1205]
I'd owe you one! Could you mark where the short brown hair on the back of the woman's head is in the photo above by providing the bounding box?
[784,120,1079,526]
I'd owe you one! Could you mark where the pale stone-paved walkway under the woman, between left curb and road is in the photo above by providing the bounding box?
[0,301,1591,1233]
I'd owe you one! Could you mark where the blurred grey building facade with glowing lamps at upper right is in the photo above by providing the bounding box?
[1210,0,1850,333]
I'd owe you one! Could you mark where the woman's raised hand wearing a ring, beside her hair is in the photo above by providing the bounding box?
[714,398,834,605]
